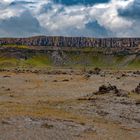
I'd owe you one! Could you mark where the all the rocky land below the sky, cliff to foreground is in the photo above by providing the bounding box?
[0,36,140,140]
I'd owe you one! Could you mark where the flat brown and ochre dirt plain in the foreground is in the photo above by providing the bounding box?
[0,69,140,140]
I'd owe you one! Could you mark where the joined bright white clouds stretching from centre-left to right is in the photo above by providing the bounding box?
[33,0,134,36]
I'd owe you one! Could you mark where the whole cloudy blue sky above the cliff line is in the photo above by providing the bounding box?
[0,0,140,37]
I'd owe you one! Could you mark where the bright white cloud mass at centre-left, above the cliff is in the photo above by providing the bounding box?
[37,5,89,30]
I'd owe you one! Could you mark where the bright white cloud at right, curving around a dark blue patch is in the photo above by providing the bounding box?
[90,0,133,32]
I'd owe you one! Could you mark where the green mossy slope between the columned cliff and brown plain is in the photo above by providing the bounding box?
[0,48,140,69]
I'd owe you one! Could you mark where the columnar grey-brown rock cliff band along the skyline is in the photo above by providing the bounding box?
[0,36,140,48]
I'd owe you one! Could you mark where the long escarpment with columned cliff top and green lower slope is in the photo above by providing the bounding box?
[0,36,140,68]
